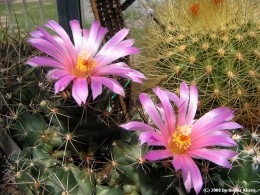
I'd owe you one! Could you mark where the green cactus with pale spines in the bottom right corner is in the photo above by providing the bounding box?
[212,127,260,194]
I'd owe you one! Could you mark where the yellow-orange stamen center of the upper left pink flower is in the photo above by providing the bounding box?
[73,50,97,77]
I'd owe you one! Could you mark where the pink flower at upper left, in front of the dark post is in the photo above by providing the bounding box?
[27,20,145,105]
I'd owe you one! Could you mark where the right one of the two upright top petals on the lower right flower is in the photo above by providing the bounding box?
[185,85,198,124]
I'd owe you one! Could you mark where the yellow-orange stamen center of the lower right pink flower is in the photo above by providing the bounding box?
[169,125,191,154]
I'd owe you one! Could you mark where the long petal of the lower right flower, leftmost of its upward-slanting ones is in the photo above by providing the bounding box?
[139,93,167,134]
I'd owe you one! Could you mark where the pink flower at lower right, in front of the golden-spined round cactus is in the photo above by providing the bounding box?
[121,82,242,194]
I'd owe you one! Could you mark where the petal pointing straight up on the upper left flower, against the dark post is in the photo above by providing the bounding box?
[70,20,83,53]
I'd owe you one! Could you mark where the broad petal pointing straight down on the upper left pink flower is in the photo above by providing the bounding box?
[72,78,88,105]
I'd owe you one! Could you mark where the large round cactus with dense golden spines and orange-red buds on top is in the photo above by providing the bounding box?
[137,0,260,126]
